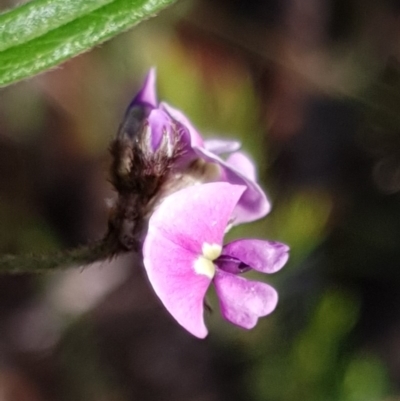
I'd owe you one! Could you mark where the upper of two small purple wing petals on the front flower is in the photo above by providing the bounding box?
[218,239,289,273]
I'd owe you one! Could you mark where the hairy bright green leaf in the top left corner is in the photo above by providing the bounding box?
[0,0,174,85]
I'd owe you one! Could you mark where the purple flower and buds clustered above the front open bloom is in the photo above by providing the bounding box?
[119,69,270,224]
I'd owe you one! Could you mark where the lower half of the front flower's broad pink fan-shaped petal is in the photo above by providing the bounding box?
[143,225,211,338]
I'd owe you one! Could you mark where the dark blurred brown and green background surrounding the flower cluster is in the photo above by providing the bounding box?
[0,0,400,401]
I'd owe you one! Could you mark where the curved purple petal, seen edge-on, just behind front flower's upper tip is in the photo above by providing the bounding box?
[194,147,271,224]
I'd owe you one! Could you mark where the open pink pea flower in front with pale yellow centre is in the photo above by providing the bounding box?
[143,182,289,338]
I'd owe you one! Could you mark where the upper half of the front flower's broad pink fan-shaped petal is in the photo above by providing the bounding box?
[149,182,245,255]
